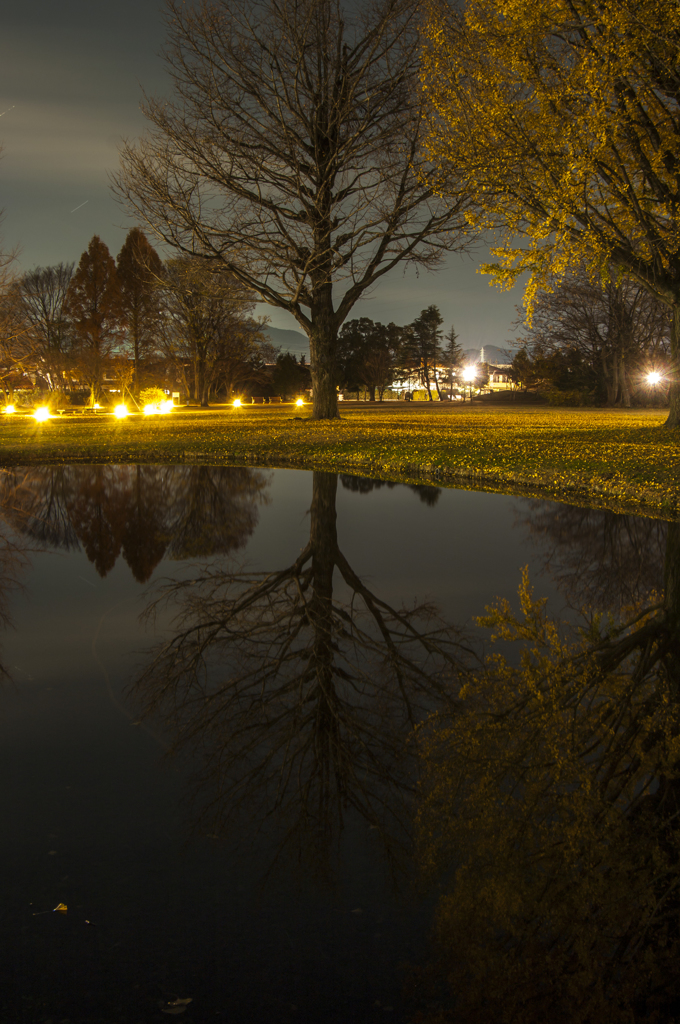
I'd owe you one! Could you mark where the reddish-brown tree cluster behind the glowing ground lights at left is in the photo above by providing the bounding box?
[0,227,275,406]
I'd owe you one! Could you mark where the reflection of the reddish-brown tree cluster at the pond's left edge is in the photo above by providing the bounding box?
[0,466,270,583]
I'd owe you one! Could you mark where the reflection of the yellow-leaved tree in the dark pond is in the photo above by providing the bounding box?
[418,516,680,1024]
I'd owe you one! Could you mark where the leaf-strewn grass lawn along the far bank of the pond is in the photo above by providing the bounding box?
[0,402,680,518]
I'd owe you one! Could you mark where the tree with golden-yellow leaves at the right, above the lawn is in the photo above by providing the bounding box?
[422,0,680,427]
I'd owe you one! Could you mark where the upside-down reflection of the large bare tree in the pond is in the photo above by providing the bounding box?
[136,472,467,868]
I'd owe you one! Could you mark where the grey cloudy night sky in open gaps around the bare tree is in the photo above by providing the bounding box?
[0,0,521,348]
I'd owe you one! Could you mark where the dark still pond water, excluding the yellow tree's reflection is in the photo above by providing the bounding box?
[0,466,667,1024]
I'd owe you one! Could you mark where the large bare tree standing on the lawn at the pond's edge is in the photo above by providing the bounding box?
[114,0,471,419]
